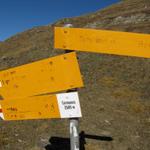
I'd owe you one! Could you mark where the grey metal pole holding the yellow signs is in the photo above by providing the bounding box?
[64,24,80,150]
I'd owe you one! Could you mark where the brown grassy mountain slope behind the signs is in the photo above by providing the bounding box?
[0,0,150,150]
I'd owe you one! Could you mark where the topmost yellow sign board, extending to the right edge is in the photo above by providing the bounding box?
[55,27,150,58]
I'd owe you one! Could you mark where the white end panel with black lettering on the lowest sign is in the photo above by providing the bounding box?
[56,92,82,118]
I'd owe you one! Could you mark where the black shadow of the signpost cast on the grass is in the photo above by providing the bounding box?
[45,131,113,150]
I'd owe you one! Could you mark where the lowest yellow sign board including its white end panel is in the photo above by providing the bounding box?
[0,92,81,120]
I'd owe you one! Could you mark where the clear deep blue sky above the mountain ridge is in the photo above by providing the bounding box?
[0,0,119,41]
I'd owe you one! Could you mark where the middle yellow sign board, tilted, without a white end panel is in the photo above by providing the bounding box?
[0,52,83,99]
